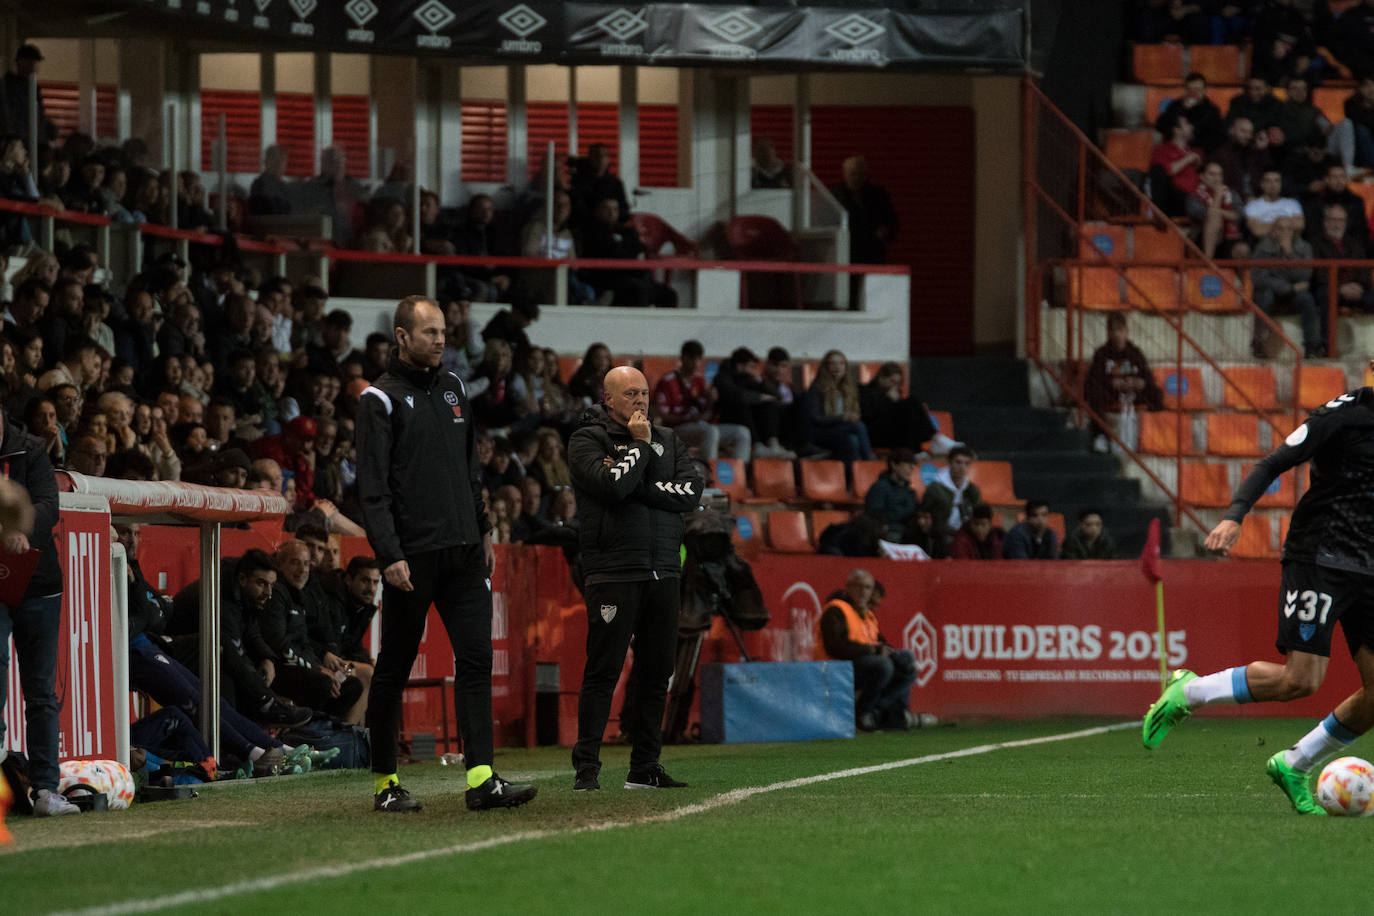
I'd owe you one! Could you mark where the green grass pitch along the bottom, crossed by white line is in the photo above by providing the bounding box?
[0,718,1374,915]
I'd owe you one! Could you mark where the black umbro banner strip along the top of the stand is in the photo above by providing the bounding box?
[29,0,1029,71]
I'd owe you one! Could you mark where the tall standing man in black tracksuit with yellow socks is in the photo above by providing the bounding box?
[357,295,534,812]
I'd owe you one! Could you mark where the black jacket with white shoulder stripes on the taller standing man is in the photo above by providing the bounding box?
[356,357,492,570]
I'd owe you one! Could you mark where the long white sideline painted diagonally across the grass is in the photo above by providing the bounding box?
[59,720,1140,916]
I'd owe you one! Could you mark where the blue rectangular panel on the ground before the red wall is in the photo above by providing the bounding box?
[701,662,855,744]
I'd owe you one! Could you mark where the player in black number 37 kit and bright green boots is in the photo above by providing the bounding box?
[1142,379,1374,814]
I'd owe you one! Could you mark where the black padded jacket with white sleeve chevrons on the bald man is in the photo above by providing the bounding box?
[567,405,703,582]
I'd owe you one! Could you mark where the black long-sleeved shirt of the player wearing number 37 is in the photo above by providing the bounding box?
[1226,387,1374,575]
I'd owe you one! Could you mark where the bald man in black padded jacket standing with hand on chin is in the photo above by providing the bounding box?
[567,367,703,791]
